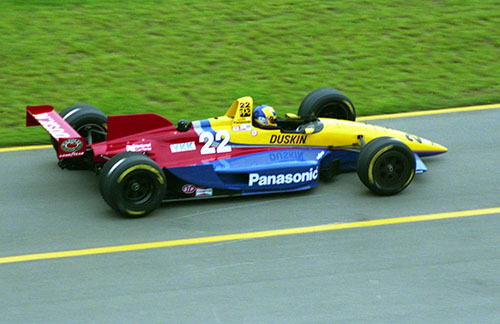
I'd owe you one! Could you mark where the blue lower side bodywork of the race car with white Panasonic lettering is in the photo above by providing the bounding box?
[168,148,427,195]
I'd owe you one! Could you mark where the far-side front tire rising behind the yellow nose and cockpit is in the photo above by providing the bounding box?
[298,88,356,121]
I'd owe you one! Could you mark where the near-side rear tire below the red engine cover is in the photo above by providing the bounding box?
[99,152,167,218]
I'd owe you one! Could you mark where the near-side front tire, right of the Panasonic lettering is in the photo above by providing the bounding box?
[357,137,416,196]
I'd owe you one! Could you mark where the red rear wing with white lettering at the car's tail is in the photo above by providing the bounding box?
[26,106,86,159]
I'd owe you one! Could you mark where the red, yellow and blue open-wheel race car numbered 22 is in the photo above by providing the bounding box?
[26,88,447,217]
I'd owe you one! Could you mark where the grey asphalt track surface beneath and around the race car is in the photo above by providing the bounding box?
[0,105,500,323]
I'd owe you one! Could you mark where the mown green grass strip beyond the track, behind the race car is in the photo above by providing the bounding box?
[0,0,500,146]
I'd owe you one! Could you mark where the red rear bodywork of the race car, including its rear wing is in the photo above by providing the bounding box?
[26,106,270,168]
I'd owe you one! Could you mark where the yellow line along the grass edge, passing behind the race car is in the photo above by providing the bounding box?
[0,103,500,153]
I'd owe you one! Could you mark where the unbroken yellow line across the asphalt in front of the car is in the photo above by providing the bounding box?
[0,207,500,264]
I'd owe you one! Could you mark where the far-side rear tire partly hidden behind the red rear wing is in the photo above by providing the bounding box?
[52,104,108,151]
